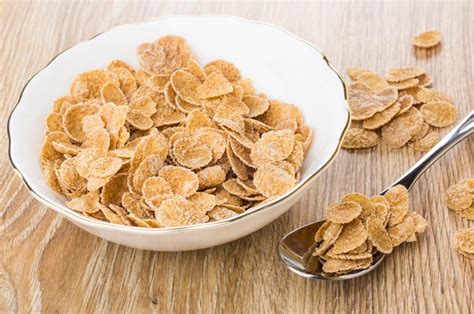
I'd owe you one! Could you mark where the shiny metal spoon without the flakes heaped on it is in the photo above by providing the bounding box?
[278,111,474,280]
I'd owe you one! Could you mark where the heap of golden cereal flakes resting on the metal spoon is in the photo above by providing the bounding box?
[313,185,427,275]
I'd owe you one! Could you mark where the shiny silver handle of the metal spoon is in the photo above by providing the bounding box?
[380,111,474,195]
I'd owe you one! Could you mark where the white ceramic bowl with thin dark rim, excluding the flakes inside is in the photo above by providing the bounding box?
[8,16,350,251]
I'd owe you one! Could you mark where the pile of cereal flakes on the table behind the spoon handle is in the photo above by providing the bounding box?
[342,67,458,152]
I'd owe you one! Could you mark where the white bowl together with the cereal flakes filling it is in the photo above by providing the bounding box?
[8,16,350,251]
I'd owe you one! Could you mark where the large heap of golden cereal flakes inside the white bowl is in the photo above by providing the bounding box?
[40,36,312,227]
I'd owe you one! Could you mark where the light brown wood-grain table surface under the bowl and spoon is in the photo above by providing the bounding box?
[0,0,474,313]
